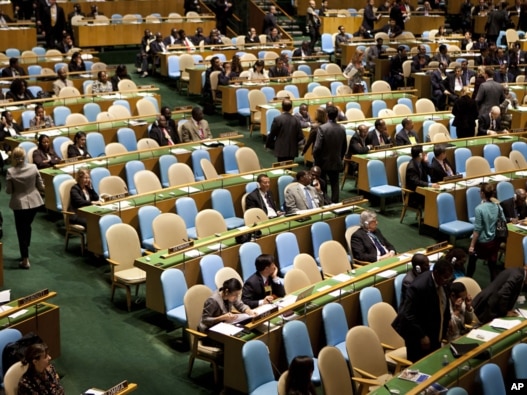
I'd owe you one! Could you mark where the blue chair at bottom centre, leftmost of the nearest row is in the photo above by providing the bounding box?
[242,340,278,394]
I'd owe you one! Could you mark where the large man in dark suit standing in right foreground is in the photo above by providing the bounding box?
[392,258,454,362]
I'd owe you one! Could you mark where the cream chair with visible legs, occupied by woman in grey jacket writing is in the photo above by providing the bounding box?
[183,284,223,384]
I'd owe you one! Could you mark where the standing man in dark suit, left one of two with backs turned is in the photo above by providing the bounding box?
[265,99,304,162]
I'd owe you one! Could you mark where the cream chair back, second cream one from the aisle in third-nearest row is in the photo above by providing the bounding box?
[152,213,188,250]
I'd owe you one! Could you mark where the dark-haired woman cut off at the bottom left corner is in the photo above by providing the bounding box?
[18,343,64,395]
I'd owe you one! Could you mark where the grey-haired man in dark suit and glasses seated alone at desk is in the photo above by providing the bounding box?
[351,210,395,262]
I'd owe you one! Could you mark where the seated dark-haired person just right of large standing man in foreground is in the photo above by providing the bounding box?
[447,282,474,342]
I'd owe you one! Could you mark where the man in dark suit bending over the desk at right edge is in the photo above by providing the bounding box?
[472,266,527,324]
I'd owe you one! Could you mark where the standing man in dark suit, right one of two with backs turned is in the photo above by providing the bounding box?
[313,106,347,203]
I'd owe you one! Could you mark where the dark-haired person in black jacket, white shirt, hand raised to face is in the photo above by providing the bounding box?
[242,254,285,308]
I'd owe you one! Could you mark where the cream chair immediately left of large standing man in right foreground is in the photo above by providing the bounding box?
[368,302,406,369]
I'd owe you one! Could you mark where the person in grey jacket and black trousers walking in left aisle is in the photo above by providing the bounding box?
[6,147,44,269]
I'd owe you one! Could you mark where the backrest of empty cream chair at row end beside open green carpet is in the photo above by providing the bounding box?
[106,224,141,272]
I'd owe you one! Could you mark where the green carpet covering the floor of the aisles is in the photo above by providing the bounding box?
[0,53,488,395]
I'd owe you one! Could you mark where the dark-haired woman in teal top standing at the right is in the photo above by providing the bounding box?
[467,182,505,281]
